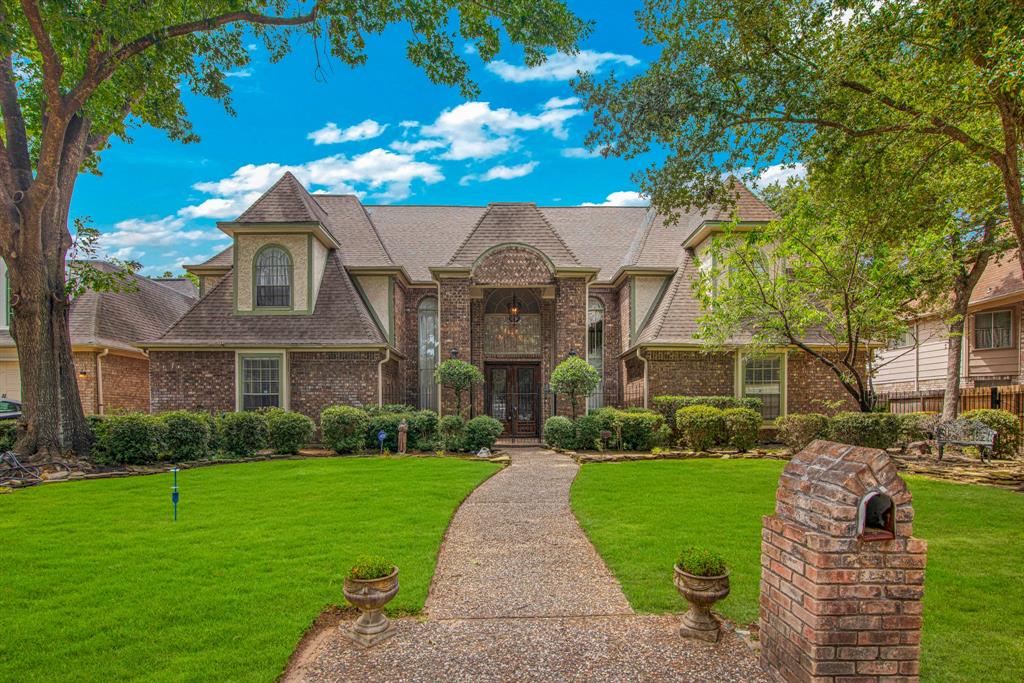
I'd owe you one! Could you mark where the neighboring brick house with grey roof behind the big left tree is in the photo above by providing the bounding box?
[0,261,198,415]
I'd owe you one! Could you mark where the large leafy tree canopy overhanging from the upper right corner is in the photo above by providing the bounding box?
[578,0,1024,268]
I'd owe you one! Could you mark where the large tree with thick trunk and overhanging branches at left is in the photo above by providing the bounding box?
[0,0,589,454]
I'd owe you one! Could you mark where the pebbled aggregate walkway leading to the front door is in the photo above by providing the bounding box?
[286,450,768,683]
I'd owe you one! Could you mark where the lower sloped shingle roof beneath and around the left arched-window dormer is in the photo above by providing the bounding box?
[145,252,386,347]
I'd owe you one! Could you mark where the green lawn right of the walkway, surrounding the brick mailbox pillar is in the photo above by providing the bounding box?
[572,460,1024,683]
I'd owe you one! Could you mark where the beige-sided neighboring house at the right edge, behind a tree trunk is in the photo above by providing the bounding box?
[874,252,1024,393]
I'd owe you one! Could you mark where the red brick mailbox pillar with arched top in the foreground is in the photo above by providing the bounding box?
[760,441,927,683]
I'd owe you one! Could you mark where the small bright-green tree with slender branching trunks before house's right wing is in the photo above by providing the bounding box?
[697,181,942,412]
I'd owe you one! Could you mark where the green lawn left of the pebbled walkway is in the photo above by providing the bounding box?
[0,458,498,682]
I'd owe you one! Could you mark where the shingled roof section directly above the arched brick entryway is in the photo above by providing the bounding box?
[447,202,581,267]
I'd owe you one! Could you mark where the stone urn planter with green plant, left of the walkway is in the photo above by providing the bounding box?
[342,556,398,647]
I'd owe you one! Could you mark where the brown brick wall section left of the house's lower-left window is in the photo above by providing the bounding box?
[150,350,236,413]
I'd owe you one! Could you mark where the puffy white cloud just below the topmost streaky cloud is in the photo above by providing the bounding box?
[420,98,583,161]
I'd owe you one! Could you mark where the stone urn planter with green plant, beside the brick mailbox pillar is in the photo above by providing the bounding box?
[675,548,729,643]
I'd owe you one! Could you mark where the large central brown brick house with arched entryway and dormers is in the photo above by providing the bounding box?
[141,174,864,436]
